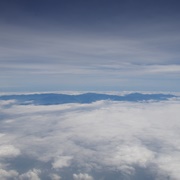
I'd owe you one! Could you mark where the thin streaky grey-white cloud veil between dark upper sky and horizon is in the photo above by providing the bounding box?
[0,24,179,91]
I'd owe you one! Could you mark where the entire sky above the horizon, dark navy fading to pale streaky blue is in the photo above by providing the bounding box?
[0,0,180,92]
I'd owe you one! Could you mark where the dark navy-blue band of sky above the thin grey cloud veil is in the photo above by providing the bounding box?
[0,0,180,33]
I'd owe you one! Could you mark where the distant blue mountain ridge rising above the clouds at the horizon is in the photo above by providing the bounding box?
[0,93,177,105]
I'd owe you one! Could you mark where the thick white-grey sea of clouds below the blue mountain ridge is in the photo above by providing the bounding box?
[0,93,180,180]
